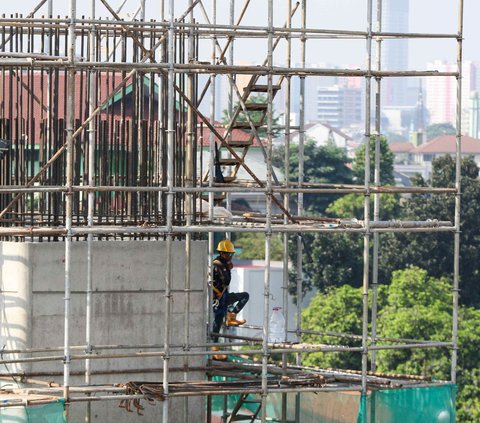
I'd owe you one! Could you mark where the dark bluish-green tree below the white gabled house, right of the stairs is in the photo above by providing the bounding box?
[272,139,352,214]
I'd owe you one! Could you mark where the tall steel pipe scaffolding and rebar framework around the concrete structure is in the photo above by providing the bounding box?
[0,0,463,422]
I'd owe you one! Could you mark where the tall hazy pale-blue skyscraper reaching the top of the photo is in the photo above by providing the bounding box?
[382,0,409,106]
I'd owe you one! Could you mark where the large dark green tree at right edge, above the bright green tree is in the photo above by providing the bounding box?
[379,156,480,306]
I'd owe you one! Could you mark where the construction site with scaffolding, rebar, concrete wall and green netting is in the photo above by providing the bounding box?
[0,0,463,423]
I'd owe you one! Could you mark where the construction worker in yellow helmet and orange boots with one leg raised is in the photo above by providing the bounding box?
[212,239,249,360]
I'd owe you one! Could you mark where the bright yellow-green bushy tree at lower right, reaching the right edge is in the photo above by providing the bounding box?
[377,267,480,423]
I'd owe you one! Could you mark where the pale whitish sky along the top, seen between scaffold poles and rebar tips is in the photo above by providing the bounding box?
[1,0,480,70]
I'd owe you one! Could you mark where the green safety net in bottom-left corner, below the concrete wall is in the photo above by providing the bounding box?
[0,399,67,423]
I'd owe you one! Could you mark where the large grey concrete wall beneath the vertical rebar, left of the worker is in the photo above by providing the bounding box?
[0,241,207,423]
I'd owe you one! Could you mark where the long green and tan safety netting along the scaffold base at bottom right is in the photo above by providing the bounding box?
[212,384,456,423]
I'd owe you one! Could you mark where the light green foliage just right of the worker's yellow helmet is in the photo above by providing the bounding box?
[234,232,283,260]
